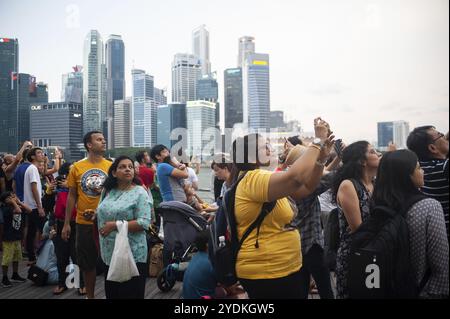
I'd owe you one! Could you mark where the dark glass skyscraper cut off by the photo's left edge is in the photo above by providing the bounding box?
[0,38,19,152]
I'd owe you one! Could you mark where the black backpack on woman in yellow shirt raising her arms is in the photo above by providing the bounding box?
[209,174,276,285]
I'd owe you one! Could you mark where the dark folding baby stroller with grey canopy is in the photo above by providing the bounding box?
[157,201,207,292]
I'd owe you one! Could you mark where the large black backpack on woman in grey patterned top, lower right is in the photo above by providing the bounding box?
[348,194,429,299]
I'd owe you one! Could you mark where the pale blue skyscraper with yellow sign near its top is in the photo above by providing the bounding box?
[242,53,270,130]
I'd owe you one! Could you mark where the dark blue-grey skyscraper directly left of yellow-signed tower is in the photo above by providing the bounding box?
[224,68,243,128]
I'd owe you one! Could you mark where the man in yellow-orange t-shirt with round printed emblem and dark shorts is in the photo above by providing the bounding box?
[62,131,111,299]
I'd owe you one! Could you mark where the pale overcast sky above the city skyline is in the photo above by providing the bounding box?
[0,0,449,141]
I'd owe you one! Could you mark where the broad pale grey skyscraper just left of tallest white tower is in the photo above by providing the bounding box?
[172,53,201,103]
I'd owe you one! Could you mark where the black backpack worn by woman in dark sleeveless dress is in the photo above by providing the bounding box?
[324,179,364,270]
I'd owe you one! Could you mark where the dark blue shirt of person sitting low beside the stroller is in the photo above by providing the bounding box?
[183,251,217,299]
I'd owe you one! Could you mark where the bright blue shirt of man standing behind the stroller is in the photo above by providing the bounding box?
[156,163,186,202]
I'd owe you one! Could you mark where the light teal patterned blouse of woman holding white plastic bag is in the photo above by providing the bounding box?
[97,186,151,265]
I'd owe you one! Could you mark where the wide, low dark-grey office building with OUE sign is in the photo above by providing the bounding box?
[30,102,84,162]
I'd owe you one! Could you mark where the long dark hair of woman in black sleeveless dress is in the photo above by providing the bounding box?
[331,141,369,203]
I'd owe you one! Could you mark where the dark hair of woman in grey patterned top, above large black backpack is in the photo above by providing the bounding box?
[372,150,419,211]
